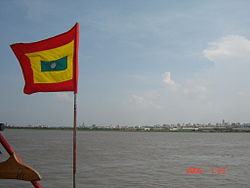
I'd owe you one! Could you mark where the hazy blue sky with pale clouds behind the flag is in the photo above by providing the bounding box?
[0,0,250,126]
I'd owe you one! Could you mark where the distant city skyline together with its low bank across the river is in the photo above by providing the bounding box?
[6,120,250,133]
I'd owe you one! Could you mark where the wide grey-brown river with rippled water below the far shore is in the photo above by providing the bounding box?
[0,129,250,188]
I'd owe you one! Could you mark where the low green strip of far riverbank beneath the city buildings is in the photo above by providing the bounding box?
[5,125,250,133]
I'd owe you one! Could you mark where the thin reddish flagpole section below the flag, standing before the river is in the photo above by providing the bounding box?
[73,93,77,188]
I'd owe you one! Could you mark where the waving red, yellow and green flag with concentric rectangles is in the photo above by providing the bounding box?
[10,23,79,94]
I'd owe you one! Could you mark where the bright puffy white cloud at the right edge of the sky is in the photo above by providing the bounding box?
[203,35,250,83]
